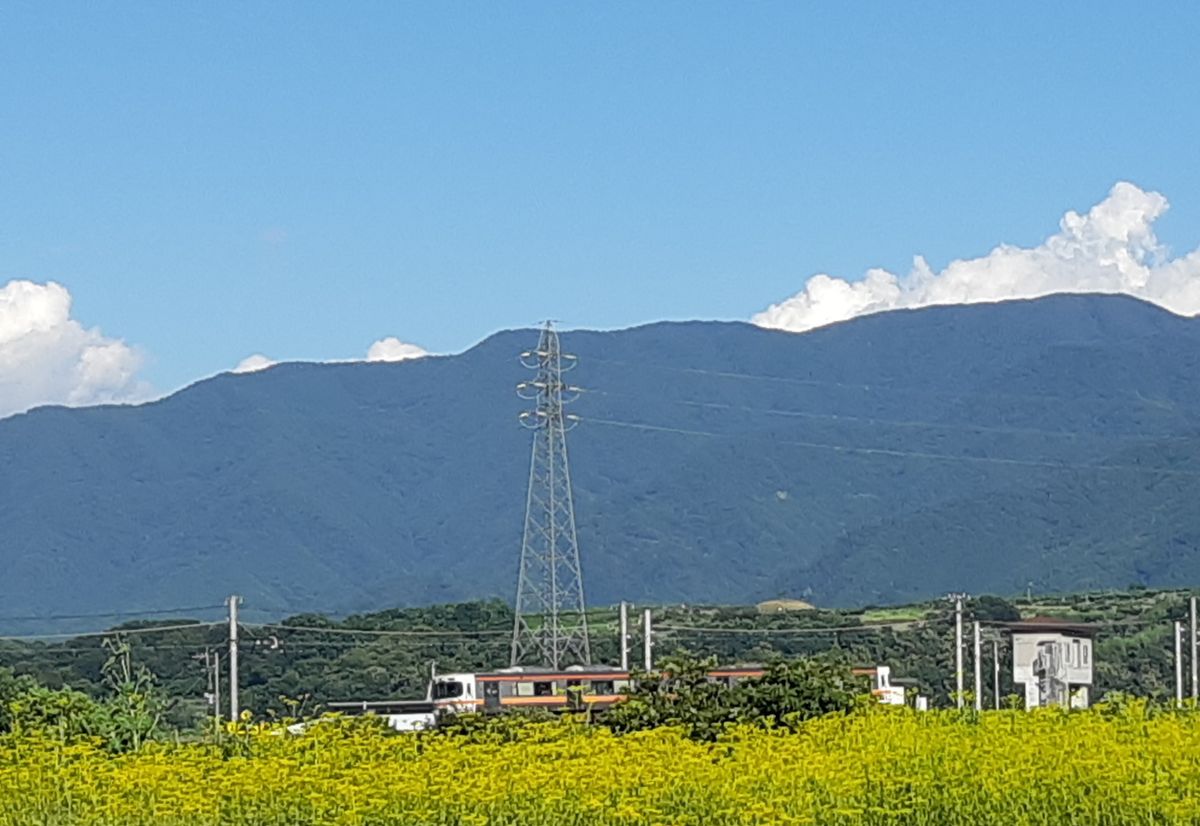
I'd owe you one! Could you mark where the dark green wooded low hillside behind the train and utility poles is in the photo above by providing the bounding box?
[0,589,1189,741]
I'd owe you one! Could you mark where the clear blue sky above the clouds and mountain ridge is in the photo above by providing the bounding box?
[0,2,1200,398]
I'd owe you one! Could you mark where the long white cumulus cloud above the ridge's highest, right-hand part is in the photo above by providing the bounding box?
[751,182,1200,331]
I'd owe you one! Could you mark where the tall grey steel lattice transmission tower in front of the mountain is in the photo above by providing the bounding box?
[511,322,592,669]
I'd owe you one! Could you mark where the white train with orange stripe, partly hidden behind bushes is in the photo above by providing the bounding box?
[326,665,905,731]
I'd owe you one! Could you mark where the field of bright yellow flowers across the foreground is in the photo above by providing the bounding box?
[0,707,1200,826]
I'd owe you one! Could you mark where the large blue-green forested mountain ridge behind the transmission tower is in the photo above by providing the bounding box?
[0,295,1200,630]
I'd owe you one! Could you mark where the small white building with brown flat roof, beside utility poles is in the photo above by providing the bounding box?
[1008,617,1096,708]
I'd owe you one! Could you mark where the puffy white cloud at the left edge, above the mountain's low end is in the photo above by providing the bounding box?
[0,281,150,417]
